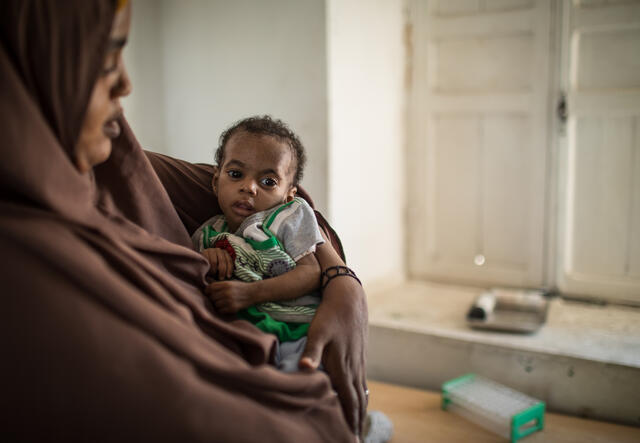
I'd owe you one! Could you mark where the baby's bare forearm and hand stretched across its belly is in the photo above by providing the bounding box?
[205,254,320,314]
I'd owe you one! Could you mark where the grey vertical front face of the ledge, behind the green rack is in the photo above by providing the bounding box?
[367,324,640,426]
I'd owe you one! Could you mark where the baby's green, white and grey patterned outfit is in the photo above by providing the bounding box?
[192,197,323,350]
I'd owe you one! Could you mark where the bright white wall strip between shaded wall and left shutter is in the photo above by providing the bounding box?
[327,0,405,286]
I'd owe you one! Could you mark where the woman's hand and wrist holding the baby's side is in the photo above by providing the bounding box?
[299,239,368,435]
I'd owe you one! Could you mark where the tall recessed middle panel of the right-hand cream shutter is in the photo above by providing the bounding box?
[570,117,633,278]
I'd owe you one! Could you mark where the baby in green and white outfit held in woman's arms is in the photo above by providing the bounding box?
[192,116,323,372]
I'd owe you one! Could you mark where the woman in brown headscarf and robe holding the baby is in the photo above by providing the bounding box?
[0,0,366,442]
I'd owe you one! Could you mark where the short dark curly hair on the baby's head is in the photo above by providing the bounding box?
[215,115,307,186]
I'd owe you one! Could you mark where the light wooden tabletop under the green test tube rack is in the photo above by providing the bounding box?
[369,381,640,443]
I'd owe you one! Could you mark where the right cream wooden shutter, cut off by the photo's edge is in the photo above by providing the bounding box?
[558,0,640,302]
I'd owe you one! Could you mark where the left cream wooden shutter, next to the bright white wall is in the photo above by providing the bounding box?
[408,0,551,287]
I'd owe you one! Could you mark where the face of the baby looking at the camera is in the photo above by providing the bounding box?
[213,131,297,232]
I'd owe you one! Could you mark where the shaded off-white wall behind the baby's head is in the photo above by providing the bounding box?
[125,0,327,211]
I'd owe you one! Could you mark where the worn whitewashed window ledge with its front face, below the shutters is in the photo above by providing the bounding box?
[367,282,640,426]
